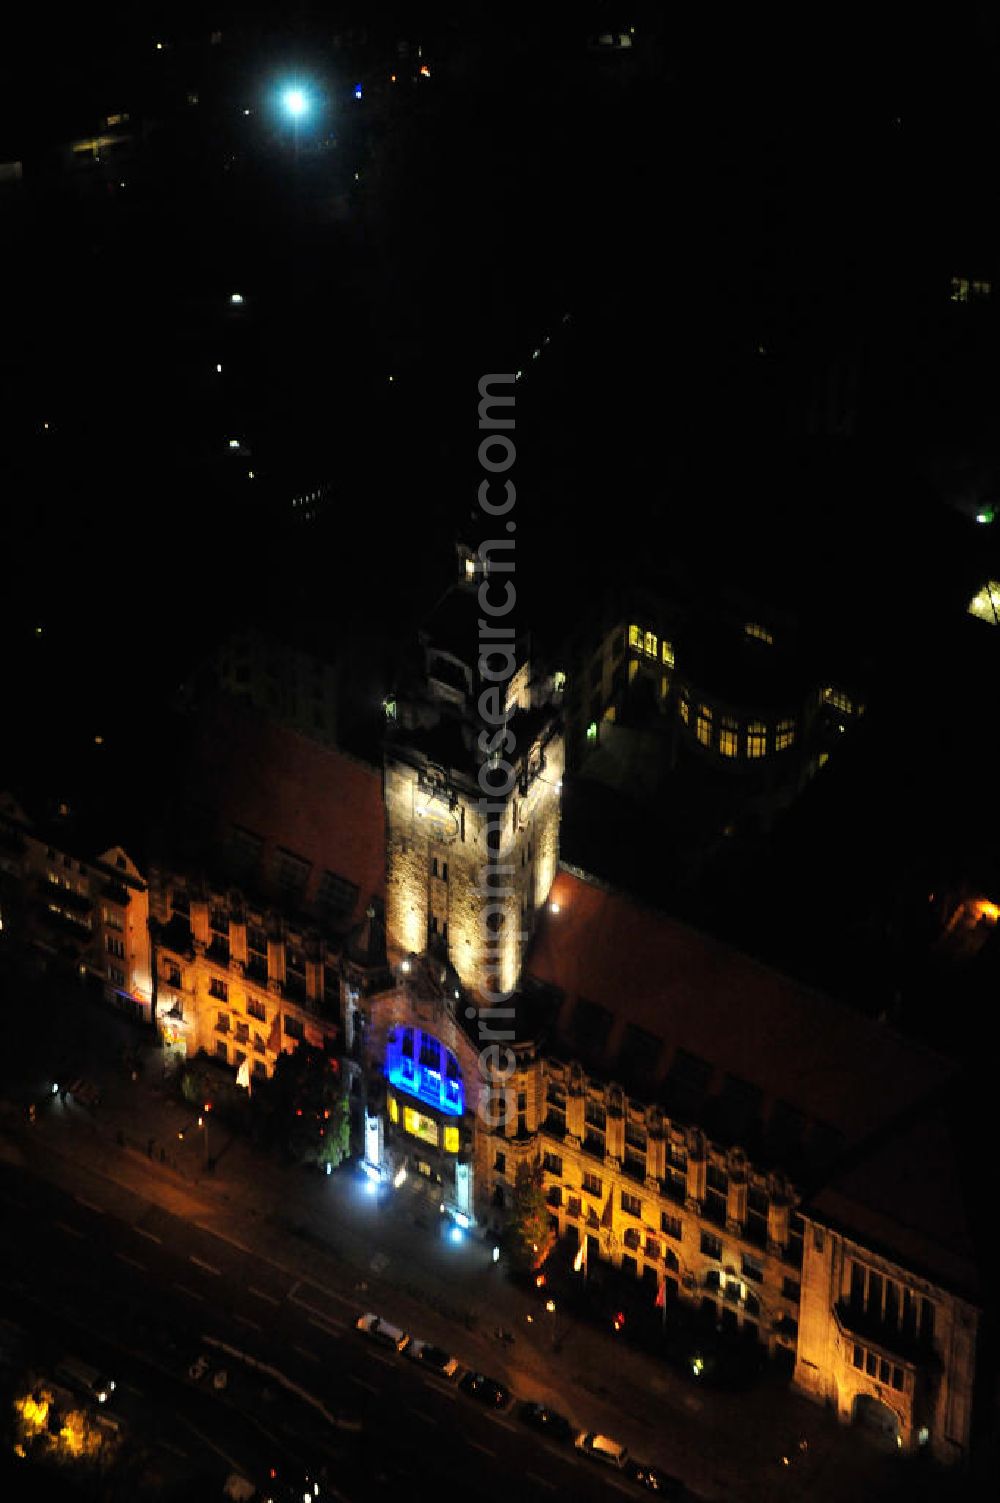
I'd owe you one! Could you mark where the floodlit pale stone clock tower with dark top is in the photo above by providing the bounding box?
[385,553,564,990]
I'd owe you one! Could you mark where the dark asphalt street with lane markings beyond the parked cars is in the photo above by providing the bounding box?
[0,1165,670,1500]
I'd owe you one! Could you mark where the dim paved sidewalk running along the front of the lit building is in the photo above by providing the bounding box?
[13,1058,890,1503]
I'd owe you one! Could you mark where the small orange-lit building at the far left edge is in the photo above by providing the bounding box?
[0,794,152,1022]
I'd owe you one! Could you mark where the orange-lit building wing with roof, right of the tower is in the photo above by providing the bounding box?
[463,869,979,1461]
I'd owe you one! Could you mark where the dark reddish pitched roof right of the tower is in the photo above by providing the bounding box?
[525,867,950,1171]
